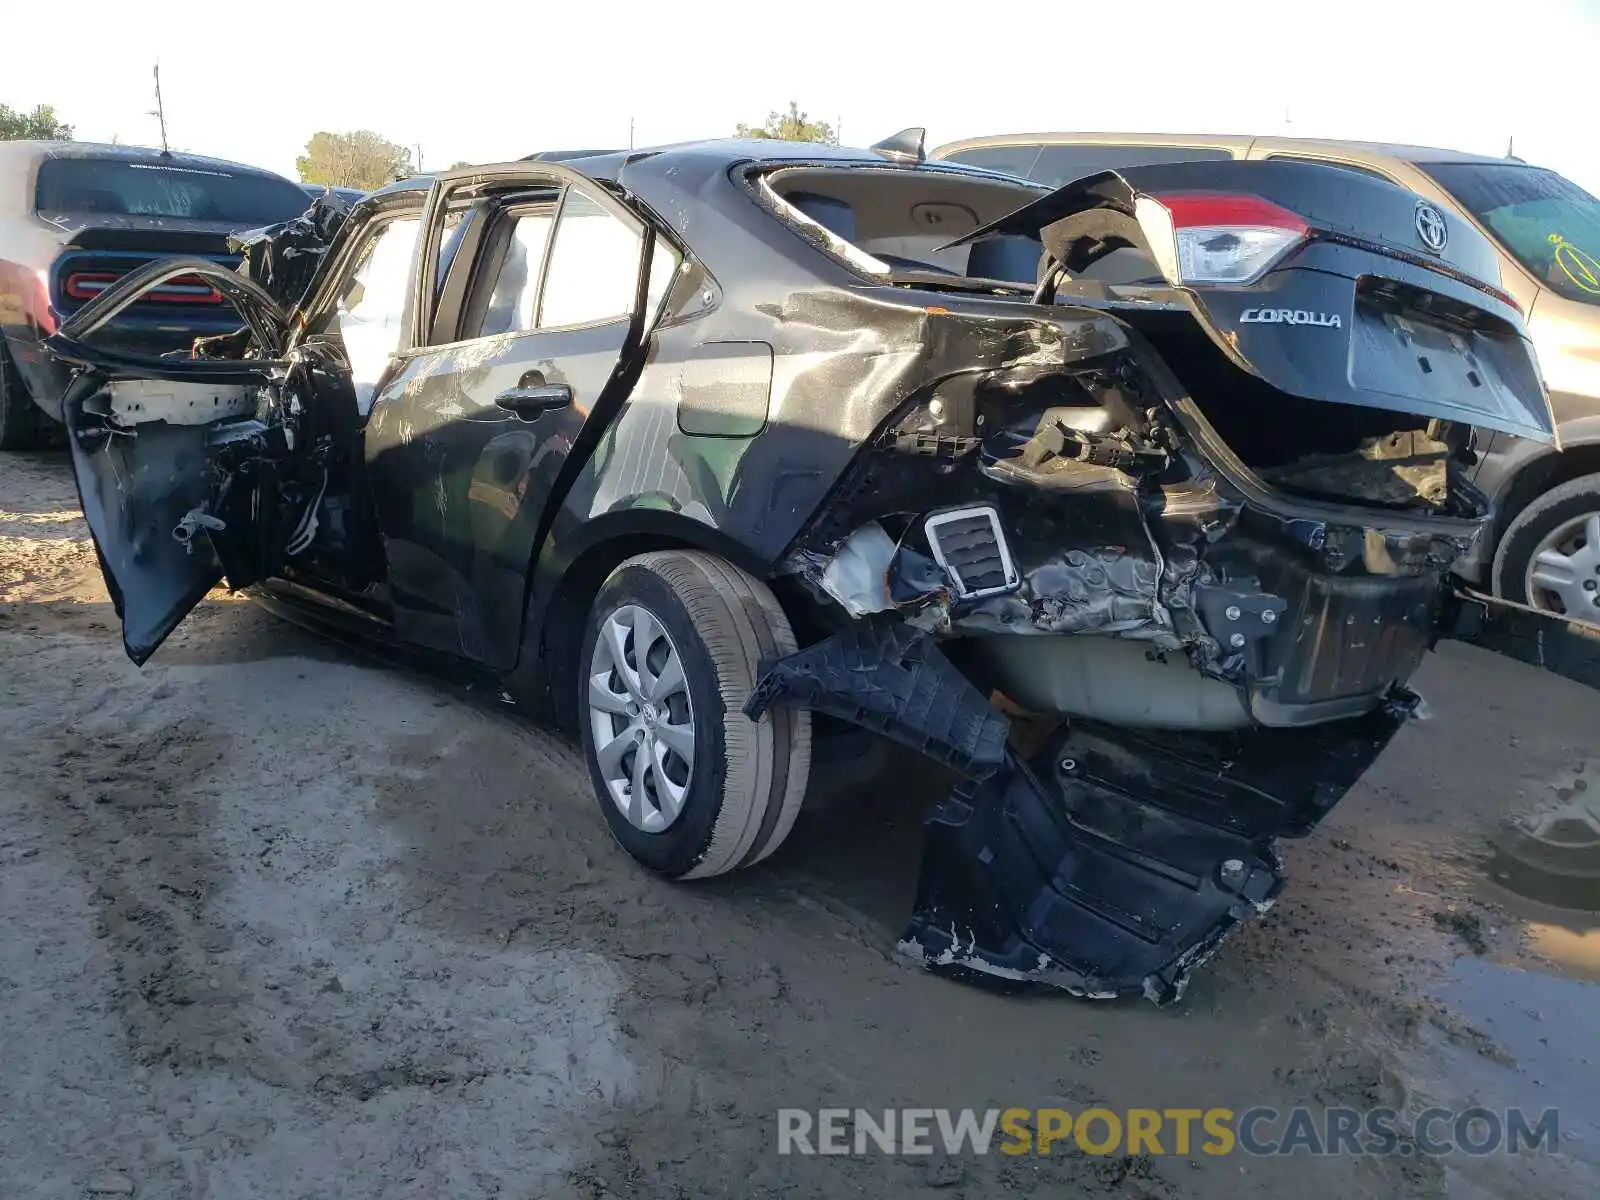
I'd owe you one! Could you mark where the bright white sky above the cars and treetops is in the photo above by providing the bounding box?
[9,0,1600,194]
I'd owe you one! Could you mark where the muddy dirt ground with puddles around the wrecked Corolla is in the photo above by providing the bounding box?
[0,454,1600,1200]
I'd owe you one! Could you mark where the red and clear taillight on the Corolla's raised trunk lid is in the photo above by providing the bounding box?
[1134,192,1309,283]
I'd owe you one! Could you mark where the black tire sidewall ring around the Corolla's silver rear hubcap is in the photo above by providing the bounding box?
[578,566,728,878]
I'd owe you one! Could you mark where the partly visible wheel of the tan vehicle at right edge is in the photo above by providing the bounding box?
[1494,475,1600,624]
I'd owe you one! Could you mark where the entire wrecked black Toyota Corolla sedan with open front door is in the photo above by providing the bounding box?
[51,141,1552,1002]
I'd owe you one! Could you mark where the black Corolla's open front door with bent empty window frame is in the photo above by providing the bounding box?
[46,259,292,664]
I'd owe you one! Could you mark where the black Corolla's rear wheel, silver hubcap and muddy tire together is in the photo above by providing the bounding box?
[578,550,811,880]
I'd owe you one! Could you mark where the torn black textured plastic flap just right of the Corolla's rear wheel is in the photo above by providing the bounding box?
[744,613,1010,778]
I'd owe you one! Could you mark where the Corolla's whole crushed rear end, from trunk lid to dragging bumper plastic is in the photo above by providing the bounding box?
[746,163,1554,1003]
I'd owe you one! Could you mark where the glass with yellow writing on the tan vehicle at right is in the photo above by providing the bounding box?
[1424,163,1600,304]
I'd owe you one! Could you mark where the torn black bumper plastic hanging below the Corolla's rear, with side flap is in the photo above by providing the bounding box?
[744,614,1418,1005]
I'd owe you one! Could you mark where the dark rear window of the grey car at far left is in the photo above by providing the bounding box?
[35,158,310,229]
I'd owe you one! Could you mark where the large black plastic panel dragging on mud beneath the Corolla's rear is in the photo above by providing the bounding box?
[899,693,1416,1005]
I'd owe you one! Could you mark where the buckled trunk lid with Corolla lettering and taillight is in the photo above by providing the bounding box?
[950,162,1555,442]
